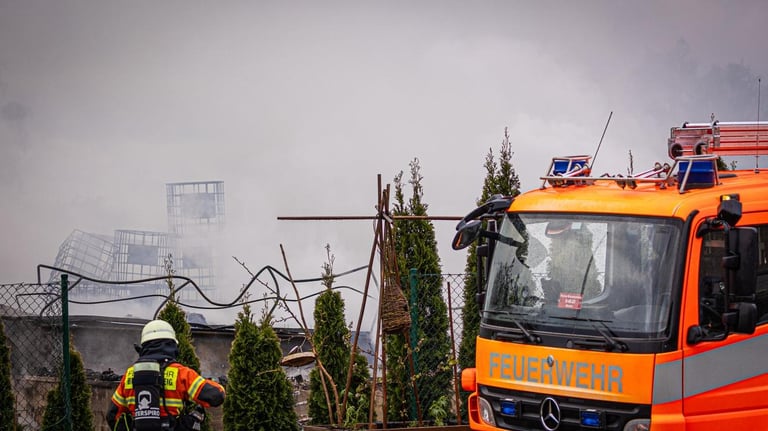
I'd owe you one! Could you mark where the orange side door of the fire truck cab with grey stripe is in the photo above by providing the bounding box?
[683,214,768,430]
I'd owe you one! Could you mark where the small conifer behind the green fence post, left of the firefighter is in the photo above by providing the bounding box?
[42,341,93,431]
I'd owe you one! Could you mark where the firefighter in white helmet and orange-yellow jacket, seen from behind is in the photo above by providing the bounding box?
[107,320,225,431]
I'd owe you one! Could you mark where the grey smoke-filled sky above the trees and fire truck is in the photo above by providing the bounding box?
[0,0,768,324]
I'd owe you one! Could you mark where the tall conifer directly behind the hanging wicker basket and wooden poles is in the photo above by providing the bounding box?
[387,159,452,420]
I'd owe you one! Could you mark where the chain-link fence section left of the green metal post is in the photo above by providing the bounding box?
[0,283,64,431]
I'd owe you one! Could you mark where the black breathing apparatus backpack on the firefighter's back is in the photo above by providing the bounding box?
[133,359,169,431]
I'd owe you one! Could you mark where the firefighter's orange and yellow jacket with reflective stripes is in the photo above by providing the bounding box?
[107,345,225,429]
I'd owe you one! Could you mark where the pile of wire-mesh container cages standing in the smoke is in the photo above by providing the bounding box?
[50,181,224,303]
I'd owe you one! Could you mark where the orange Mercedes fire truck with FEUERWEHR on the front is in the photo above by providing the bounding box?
[452,122,768,431]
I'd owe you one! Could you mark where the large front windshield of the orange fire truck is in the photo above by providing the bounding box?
[483,213,682,342]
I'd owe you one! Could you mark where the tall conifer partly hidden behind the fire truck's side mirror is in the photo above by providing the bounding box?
[459,128,520,418]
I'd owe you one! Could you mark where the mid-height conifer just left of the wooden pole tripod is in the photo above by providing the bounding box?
[308,245,370,425]
